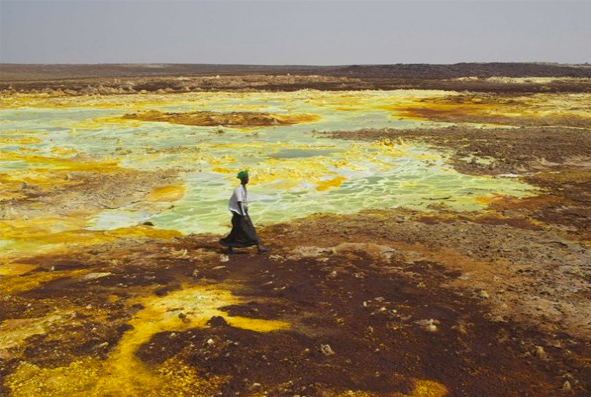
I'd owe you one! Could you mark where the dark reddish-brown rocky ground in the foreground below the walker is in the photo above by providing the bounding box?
[0,206,591,396]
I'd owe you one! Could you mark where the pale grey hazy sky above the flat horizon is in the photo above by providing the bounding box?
[0,0,591,65]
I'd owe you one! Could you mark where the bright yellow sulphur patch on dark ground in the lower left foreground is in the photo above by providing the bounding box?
[5,287,289,397]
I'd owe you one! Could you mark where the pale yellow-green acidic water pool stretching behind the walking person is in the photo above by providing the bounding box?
[0,91,535,249]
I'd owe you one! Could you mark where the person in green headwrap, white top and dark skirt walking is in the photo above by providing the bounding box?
[220,171,269,254]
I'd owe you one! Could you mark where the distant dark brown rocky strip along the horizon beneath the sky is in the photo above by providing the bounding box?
[0,63,591,95]
